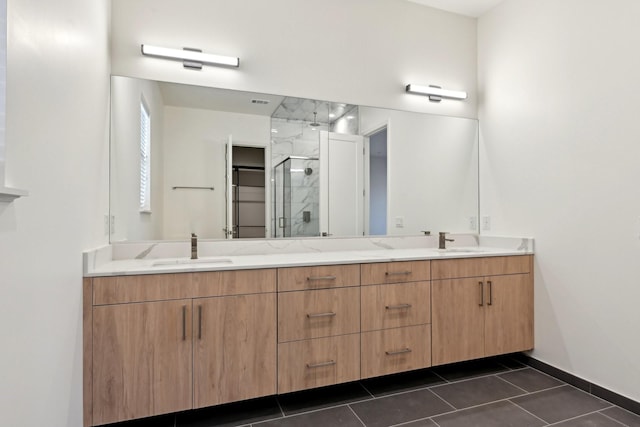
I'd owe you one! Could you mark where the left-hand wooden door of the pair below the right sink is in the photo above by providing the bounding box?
[431,278,485,366]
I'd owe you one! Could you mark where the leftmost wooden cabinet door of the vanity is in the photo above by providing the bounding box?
[92,300,192,425]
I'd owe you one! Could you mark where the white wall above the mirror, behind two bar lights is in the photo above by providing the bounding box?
[112,0,476,117]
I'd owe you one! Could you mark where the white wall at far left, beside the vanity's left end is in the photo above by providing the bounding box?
[0,0,109,427]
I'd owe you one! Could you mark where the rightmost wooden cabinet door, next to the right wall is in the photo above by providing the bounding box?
[485,274,533,356]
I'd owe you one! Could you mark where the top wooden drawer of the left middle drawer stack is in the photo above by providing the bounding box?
[278,264,360,291]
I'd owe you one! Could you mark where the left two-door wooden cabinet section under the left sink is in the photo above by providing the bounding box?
[84,270,276,426]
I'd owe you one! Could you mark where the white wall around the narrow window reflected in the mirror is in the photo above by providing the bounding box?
[109,77,164,242]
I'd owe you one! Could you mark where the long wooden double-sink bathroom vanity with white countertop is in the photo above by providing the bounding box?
[84,237,533,426]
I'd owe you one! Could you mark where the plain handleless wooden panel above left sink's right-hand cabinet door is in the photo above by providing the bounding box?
[193,268,276,298]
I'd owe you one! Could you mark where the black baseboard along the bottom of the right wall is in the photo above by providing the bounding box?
[516,353,640,415]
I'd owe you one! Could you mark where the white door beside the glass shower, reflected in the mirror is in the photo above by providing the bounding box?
[320,132,364,236]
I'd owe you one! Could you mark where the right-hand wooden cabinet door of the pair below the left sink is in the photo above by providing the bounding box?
[193,293,277,408]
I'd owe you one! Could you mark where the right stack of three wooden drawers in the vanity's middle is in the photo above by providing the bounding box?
[361,261,431,378]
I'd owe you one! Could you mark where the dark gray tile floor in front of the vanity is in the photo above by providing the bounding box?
[102,357,640,427]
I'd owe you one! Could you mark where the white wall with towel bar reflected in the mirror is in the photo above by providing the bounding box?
[163,106,271,240]
